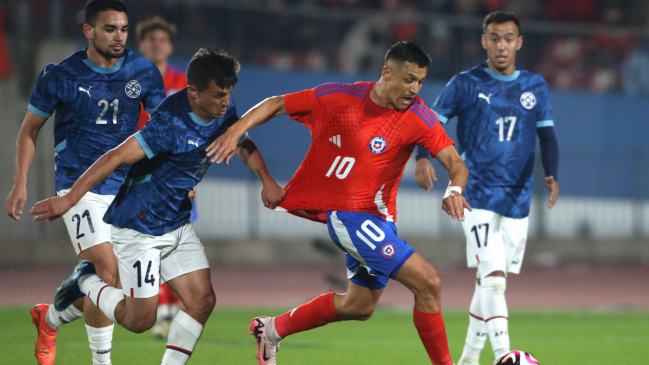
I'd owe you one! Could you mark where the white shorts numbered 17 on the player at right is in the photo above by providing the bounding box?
[462,208,529,277]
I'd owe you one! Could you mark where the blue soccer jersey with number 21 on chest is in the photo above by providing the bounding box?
[28,49,166,195]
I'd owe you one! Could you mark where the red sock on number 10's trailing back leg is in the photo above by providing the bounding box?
[275,293,340,338]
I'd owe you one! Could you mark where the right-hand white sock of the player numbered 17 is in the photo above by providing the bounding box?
[480,276,509,357]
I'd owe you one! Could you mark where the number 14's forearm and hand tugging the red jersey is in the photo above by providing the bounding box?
[237,137,286,209]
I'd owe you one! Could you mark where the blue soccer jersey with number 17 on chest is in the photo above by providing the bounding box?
[418,63,554,218]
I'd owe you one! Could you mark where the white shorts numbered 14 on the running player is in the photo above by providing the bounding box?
[111,223,210,298]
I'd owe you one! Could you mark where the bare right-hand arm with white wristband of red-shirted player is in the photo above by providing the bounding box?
[435,146,473,221]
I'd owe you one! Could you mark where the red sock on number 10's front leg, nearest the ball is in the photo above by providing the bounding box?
[413,309,453,365]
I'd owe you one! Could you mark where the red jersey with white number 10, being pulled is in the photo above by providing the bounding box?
[280,82,454,222]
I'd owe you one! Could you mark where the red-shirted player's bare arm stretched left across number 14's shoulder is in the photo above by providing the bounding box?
[206,95,287,165]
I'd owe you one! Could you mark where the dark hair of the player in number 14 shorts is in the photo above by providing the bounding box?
[187,47,241,91]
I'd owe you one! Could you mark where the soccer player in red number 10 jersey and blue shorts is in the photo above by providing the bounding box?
[206,42,471,365]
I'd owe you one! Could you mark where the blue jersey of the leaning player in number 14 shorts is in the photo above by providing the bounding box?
[104,88,248,236]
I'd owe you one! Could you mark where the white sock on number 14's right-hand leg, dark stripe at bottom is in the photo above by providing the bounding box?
[160,311,203,365]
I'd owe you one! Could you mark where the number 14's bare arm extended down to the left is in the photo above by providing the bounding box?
[29,136,146,222]
